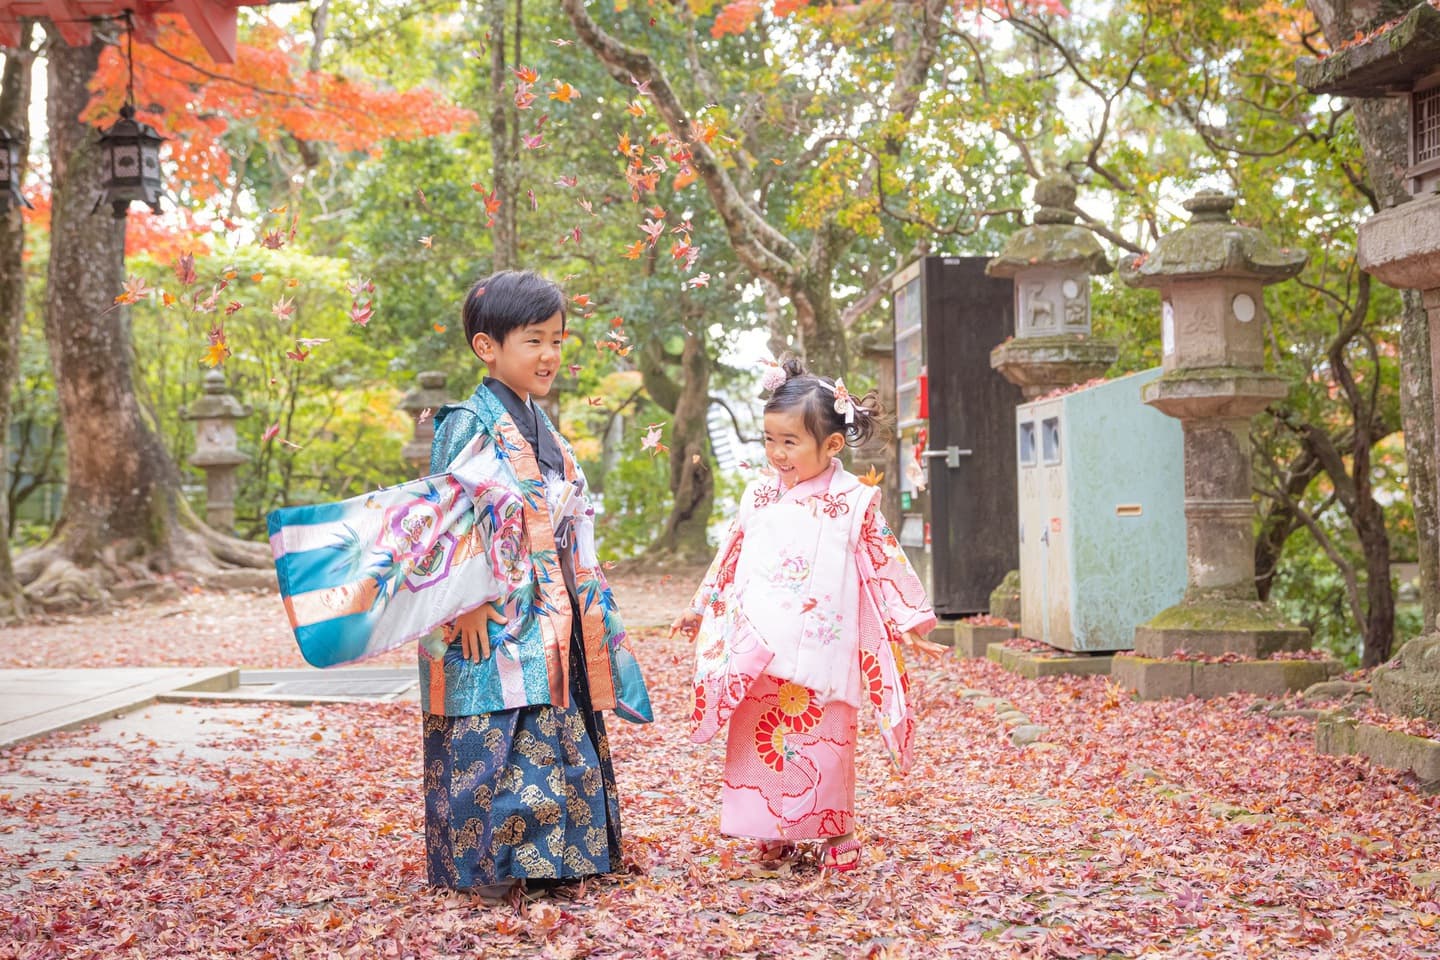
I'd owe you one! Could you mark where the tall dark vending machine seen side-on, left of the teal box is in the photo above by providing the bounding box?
[891,256,1022,617]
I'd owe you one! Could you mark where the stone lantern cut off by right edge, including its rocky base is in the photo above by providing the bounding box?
[1296,3,1440,742]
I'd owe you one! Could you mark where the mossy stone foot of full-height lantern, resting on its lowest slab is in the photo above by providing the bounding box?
[1135,600,1310,661]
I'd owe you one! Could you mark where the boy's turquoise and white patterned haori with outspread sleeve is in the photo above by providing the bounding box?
[269,386,651,723]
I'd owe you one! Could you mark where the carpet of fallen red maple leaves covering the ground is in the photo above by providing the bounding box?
[0,596,1440,960]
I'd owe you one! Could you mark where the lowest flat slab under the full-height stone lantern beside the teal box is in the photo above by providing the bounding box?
[1110,653,1342,699]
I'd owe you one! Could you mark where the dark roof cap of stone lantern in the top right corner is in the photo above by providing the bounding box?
[1295,0,1440,96]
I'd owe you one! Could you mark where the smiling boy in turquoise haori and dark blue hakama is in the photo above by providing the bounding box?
[269,271,651,900]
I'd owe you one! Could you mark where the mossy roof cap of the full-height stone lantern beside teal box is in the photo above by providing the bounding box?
[1120,190,1309,286]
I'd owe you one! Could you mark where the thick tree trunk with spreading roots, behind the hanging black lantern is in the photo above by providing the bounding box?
[16,39,268,606]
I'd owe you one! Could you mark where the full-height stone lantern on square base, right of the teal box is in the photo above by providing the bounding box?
[1112,193,1338,698]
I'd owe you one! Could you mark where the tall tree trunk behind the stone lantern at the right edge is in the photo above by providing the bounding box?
[1309,0,1440,644]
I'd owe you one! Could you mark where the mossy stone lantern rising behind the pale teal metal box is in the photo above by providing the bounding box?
[985,176,1120,400]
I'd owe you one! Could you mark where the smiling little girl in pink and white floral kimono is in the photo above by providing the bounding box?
[672,360,939,871]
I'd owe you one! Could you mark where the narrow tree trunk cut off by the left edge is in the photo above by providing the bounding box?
[0,23,35,620]
